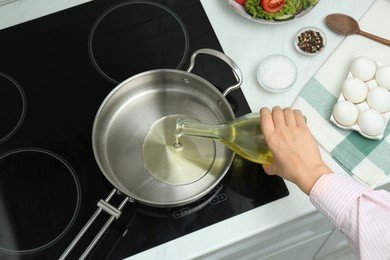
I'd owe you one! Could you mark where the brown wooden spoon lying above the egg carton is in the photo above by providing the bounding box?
[325,14,390,46]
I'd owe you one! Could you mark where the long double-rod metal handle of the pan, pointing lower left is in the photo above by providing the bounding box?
[59,189,131,260]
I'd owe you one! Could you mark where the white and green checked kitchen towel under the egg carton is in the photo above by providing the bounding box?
[293,0,390,187]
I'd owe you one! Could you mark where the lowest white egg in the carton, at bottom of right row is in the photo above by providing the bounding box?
[358,109,386,136]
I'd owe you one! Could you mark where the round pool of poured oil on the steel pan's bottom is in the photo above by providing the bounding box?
[142,115,216,185]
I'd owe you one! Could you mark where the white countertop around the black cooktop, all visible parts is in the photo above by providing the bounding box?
[0,0,388,259]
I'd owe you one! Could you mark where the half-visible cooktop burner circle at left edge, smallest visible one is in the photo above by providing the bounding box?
[0,72,27,144]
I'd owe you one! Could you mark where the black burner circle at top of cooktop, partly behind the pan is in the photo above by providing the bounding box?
[88,1,189,84]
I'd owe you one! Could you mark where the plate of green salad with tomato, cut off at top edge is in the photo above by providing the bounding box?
[227,0,319,24]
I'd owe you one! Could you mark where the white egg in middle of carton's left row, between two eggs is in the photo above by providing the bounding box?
[341,78,368,104]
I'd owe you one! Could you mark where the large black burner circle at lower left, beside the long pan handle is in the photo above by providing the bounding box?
[0,148,81,255]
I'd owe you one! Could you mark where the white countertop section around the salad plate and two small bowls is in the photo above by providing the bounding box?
[201,0,374,111]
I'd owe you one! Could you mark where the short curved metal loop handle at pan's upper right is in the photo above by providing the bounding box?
[187,49,243,97]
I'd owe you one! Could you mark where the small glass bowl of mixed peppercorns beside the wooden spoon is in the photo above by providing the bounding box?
[294,26,326,56]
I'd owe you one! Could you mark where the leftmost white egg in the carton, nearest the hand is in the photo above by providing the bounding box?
[333,100,359,126]
